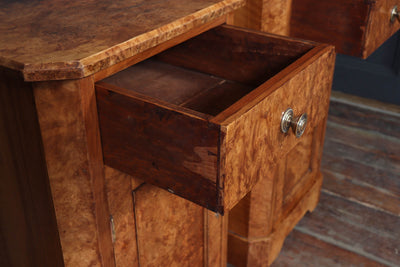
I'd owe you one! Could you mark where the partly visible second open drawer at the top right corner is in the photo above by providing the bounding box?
[289,0,400,58]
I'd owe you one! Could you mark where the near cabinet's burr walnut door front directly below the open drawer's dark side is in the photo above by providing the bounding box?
[106,167,228,266]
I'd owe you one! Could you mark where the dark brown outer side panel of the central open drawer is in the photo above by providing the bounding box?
[97,86,219,214]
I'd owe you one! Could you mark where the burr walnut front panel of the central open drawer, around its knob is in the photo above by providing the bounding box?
[221,45,335,208]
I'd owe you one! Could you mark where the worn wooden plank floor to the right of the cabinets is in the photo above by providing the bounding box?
[272,93,400,267]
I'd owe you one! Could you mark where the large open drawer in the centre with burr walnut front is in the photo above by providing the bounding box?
[96,25,335,214]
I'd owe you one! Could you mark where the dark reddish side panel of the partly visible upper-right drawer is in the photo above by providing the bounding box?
[290,0,369,56]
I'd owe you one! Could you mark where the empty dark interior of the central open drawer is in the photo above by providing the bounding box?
[103,26,314,116]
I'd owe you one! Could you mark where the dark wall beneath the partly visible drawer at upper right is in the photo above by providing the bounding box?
[332,31,400,105]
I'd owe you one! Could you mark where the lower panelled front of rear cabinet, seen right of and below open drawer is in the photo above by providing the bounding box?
[228,121,325,266]
